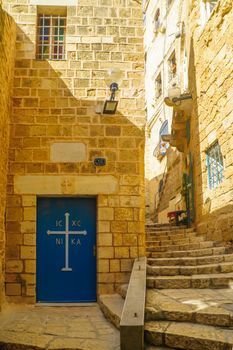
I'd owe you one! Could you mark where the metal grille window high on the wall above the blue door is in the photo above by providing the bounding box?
[36,14,66,60]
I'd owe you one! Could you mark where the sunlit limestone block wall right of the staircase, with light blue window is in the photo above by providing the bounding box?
[190,0,233,240]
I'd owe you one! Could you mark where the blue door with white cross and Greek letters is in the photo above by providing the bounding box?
[36,197,96,302]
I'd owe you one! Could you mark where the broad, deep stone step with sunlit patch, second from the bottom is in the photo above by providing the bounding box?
[145,288,233,327]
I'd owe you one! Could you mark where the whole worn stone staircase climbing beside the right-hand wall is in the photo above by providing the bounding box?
[145,224,233,350]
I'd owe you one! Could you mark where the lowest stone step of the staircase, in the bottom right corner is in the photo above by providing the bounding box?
[145,321,233,350]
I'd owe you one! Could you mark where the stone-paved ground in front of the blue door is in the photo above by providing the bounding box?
[0,304,120,350]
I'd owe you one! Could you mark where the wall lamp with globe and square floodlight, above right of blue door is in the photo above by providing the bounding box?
[103,68,122,114]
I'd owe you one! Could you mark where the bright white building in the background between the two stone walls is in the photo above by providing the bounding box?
[143,0,191,222]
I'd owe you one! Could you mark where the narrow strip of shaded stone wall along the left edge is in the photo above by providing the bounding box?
[0,5,15,308]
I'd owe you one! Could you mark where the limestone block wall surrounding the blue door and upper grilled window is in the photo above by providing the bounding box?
[3,0,144,302]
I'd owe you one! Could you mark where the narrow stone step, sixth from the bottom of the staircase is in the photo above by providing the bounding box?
[147,247,227,258]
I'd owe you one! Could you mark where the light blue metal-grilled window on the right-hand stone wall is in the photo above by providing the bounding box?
[206,142,224,189]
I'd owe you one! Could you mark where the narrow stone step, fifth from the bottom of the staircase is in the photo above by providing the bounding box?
[147,254,233,266]
